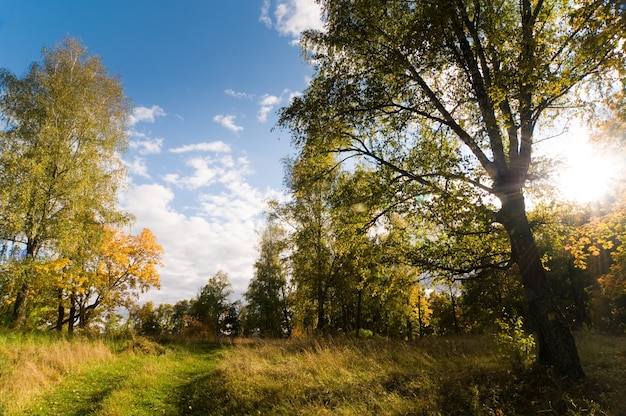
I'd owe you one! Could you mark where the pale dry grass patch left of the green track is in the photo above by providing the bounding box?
[0,332,114,414]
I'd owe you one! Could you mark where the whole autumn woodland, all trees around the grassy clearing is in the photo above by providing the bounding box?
[0,0,626,414]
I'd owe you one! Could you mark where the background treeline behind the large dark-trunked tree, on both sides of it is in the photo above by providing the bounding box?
[130,176,626,340]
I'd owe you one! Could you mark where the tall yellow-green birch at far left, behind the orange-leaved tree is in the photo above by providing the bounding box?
[0,39,129,327]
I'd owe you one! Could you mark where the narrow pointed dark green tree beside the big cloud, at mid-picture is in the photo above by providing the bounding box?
[244,217,291,338]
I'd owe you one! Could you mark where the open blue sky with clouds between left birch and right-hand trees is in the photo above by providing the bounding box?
[0,0,321,303]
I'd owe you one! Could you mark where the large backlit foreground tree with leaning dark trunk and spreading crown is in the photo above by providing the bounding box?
[281,0,624,377]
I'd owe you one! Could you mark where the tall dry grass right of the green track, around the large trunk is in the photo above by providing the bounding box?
[198,335,626,415]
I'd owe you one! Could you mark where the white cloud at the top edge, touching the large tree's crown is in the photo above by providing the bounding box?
[259,0,324,38]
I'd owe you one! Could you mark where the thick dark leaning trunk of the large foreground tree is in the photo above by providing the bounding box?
[499,192,585,378]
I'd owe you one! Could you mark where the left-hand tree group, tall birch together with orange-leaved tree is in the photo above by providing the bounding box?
[0,39,163,332]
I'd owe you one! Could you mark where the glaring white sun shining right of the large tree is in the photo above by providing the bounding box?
[555,127,624,203]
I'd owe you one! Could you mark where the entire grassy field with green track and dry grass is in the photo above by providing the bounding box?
[0,333,626,416]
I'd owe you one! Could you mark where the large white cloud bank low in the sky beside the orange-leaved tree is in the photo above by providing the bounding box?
[121,183,273,303]
